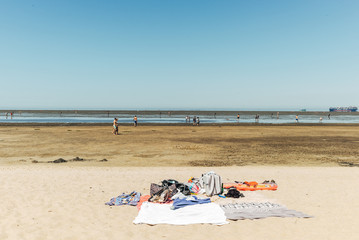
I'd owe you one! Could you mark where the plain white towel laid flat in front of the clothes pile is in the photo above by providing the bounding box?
[133,202,228,225]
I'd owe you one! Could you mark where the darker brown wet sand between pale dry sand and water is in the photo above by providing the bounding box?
[0,125,359,166]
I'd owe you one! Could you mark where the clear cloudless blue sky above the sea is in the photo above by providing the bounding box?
[0,0,359,110]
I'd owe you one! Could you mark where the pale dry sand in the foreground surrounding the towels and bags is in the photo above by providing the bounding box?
[0,165,359,240]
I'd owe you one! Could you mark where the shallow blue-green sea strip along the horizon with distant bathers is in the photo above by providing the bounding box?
[0,110,359,124]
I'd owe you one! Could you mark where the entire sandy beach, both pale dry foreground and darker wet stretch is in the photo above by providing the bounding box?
[0,126,359,239]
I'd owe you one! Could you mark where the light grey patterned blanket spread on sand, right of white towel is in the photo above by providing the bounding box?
[221,202,313,220]
